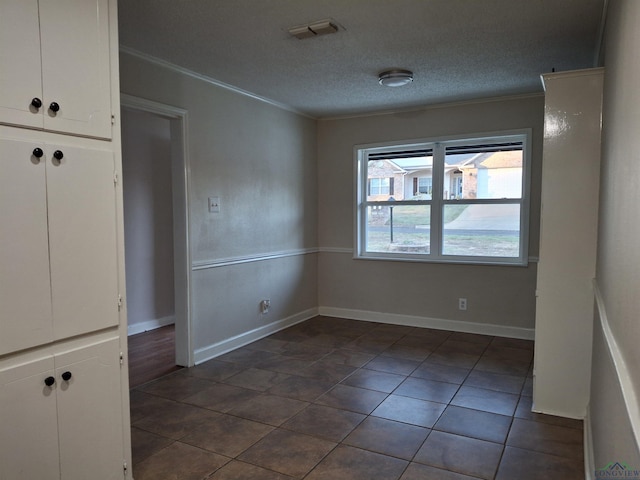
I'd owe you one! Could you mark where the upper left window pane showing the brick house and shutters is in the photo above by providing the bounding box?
[367,157,433,202]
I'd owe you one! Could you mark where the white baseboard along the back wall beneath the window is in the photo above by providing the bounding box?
[318,307,535,340]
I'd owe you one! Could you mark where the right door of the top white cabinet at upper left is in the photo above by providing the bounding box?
[40,0,111,138]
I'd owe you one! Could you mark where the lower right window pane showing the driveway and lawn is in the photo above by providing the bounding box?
[442,204,520,257]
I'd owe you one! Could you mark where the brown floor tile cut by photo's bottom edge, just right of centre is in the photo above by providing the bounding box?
[305,445,408,480]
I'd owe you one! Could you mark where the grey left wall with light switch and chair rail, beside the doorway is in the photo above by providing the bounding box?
[120,52,318,362]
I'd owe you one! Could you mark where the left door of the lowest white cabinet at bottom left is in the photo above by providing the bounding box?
[0,356,60,480]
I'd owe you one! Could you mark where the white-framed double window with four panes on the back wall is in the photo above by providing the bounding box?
[356,131,530,265]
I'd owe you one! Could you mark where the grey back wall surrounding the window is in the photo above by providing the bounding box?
[318,95,544,336]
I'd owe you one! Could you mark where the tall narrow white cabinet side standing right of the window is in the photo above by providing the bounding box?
[533,68,604,418]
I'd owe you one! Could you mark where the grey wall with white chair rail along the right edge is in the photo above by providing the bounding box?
[590,0,640,469]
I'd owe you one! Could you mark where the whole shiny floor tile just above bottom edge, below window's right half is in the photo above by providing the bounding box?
[414,431,504,480]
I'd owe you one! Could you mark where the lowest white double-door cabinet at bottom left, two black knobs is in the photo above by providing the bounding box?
[0,337,124,480]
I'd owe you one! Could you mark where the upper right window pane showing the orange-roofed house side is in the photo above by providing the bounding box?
[443,147,523,200]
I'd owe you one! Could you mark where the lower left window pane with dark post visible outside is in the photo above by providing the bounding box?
[365,205,431,254]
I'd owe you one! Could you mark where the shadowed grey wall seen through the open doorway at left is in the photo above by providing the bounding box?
[122,109,175,334]
